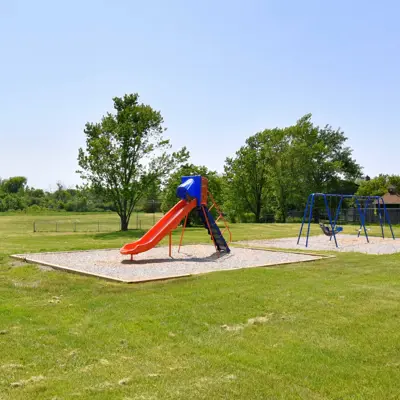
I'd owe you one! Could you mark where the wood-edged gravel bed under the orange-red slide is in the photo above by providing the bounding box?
[13,245,321,283]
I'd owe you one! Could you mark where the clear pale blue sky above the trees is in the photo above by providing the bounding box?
[0,0,400,189]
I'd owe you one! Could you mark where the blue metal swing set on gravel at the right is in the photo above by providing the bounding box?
[297,193,395,247]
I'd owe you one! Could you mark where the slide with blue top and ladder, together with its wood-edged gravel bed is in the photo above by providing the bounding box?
[12,176,328,283]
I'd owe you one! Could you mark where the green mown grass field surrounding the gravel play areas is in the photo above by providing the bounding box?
[0,214,400,400]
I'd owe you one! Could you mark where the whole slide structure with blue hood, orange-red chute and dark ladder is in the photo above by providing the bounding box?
[120,176,232,259]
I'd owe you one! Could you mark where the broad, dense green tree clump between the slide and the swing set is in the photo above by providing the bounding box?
[225,114,361,222]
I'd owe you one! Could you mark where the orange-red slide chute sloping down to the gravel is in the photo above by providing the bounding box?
[120,199,197,254]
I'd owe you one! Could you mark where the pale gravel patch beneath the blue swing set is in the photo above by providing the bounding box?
[240,234,400,254]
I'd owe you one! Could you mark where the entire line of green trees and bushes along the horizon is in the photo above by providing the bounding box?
[0,94,400,230]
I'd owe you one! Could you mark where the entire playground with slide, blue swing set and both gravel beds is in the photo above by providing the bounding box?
[12,182,400,283]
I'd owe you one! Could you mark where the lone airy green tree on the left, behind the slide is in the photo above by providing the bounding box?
[78,94,188,230]
